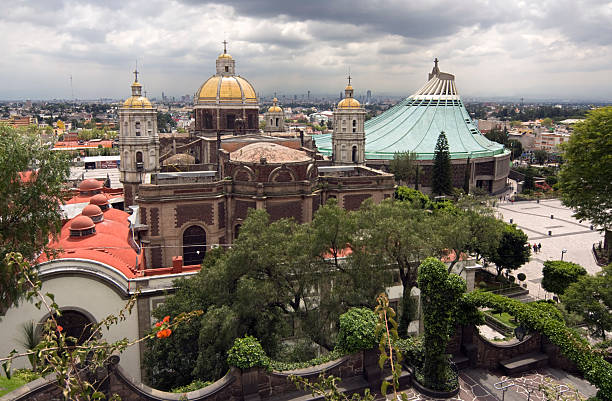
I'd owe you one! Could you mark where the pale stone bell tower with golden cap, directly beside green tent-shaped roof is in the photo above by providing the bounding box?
[332,75,366,164]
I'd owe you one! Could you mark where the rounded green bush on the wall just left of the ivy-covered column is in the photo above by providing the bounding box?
[336,308,378,354]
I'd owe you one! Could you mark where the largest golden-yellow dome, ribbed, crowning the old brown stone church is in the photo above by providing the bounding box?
[196,75,257,104]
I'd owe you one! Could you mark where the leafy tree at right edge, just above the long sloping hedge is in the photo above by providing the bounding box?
[561,264,612,340]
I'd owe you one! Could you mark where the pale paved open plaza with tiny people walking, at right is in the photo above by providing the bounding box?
[496,199,603,299]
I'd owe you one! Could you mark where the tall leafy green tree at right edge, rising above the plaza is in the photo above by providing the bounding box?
[559,107,612,260]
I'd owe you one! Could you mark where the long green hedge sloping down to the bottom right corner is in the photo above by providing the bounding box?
[464,291,612,401]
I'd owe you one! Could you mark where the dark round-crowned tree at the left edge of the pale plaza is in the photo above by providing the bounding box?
[491,223,531,276]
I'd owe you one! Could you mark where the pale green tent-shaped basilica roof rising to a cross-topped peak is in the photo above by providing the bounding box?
[313,60,507,160]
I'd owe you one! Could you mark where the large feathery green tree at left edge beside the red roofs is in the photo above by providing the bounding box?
[0,124,69,315]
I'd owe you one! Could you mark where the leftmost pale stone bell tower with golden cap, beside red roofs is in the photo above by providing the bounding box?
[119,69,159,209]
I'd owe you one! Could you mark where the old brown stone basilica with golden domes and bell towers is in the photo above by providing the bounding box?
[119,45,395,268]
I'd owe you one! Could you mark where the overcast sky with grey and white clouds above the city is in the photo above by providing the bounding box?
[0,0,612,100]
